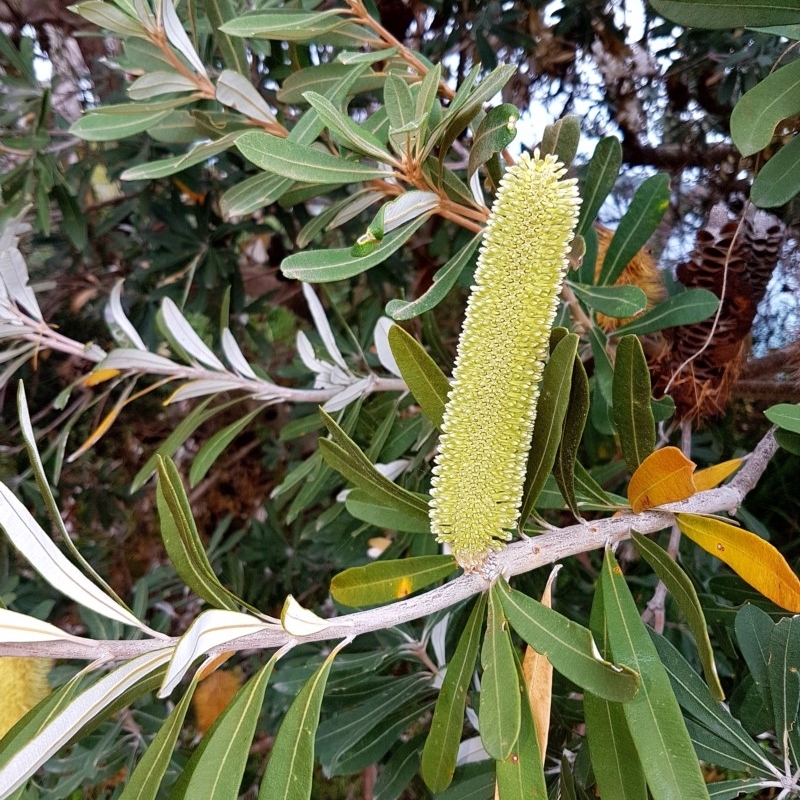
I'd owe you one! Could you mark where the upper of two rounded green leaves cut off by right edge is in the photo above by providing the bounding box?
[731,61,800,156]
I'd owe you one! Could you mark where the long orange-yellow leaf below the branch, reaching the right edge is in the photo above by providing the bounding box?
[675,514,800,613]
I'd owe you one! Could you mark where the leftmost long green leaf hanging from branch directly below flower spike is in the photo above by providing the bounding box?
[422,592,487,792]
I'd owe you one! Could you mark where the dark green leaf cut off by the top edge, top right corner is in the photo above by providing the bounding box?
[650,0,797,30]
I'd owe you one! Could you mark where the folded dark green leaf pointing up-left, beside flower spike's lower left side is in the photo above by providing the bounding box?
[319,409,428,513]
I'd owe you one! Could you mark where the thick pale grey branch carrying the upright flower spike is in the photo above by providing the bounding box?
[0,431,778,660]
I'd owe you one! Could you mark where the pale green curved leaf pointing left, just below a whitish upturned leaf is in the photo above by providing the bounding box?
[281,214,430,283]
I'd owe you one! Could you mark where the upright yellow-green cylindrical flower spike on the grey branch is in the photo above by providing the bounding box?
[430,150,580,572]
